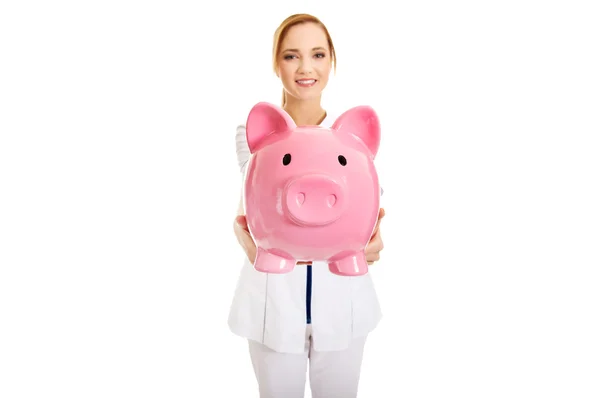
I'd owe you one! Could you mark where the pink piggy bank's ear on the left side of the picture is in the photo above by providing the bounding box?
[246,102,296,153]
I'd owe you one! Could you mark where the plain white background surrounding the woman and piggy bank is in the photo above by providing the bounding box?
[0,0,600,398]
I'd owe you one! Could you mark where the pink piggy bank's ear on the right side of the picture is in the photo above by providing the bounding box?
[332,105,381,157]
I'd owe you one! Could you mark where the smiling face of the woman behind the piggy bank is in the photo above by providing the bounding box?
[278,23,331,100]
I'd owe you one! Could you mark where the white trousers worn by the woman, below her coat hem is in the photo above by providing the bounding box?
[249,325,366,398]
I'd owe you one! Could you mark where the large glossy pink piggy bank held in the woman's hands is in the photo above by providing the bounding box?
[243,102,380,275]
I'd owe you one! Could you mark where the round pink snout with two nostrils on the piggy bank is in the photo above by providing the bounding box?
[283,175,346,226]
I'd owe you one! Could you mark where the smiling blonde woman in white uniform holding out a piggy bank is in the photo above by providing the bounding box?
[229,14,384,398]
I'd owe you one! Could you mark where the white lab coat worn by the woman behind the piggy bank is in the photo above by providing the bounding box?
[228,112,382,353]
